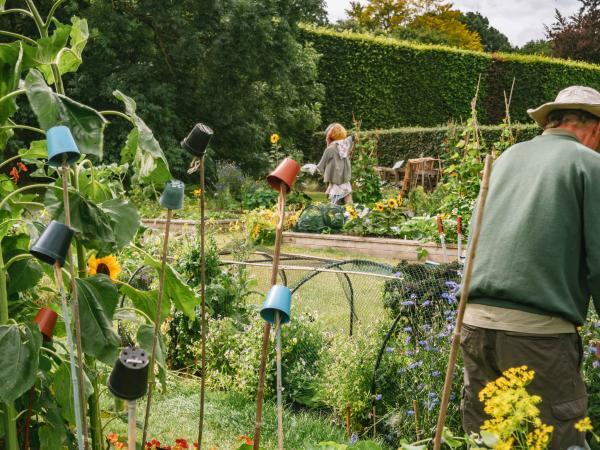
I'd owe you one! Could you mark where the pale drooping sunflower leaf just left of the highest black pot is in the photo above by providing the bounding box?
[113,91,171,183]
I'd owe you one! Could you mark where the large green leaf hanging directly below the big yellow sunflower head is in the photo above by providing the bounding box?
[76,275,120,366]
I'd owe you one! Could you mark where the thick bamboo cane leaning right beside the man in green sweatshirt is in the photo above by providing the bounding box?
[433,154,492,450]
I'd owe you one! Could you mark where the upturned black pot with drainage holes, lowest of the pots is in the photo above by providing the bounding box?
[108,347,148,400]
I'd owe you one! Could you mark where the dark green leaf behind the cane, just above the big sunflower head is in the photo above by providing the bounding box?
[44,189,117,254]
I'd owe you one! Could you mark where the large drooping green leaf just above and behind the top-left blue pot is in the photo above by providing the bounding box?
[25,69,106,159]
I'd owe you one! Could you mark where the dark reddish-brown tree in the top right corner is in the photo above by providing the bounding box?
[546,0,600,63]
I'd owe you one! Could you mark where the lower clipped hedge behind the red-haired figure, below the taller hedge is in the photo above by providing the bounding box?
[304,125,542,167]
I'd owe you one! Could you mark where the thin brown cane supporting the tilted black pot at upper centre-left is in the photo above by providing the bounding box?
[198,156,208,450]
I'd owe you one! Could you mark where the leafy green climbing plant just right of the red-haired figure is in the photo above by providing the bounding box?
[352,138,381,203]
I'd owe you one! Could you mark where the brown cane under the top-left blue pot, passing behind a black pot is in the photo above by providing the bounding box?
[61,163,89,450]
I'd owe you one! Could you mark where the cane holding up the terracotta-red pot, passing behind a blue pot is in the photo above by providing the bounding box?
[254,183,287,450]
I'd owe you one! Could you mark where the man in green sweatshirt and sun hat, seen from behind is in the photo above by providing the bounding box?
[461,86,600,450]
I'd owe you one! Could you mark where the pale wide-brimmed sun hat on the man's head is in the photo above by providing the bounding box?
[527,86,600,127]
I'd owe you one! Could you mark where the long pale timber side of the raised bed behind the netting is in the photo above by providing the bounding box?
[283,231,464,263]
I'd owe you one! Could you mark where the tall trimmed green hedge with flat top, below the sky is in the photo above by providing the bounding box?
[301,26,600,128]
